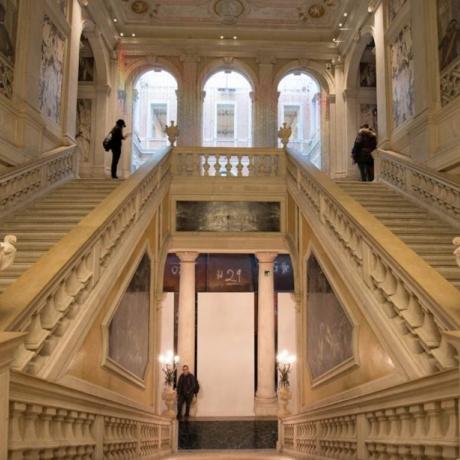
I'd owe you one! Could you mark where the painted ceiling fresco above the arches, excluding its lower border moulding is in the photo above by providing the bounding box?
[105,0,351,30]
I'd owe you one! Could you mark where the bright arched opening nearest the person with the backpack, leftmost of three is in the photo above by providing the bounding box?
[132,70,177,170]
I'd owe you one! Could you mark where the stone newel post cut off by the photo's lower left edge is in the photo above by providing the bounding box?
[0,332,26,460]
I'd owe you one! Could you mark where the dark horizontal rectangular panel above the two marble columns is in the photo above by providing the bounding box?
[176,201,280,232]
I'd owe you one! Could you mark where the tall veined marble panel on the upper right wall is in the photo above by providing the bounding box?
[390,24,415,128]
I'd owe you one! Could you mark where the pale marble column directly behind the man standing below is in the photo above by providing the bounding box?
[176,252,198,373]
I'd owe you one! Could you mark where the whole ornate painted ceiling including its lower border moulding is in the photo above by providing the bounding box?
[104,0,359,41]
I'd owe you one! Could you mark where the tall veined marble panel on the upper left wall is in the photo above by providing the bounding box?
[38,15,65,124]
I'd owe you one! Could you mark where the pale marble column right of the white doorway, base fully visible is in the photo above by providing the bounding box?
[254,252,277,415]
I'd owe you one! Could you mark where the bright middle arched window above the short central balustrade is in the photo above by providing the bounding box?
[203,71,252,147]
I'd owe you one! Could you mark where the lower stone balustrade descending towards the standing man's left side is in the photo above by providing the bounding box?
[9,372,174,460]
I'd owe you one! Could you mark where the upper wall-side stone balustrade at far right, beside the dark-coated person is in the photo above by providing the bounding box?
[374,149,460,228]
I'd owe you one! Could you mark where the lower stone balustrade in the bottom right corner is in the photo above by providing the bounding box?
[279,371,460,460]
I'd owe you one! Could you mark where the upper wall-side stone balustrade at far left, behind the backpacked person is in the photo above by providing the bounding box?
[0,145,78,217]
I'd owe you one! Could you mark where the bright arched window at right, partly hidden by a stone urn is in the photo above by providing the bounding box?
[278,73,321,168]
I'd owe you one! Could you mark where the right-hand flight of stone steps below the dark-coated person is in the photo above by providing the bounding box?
[336,180,460,289]
